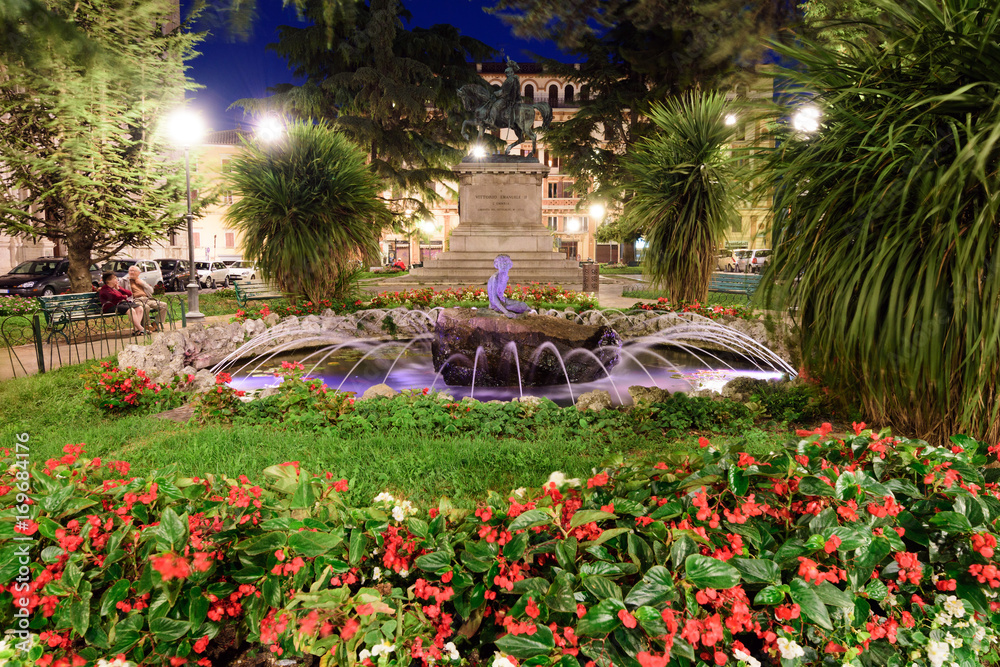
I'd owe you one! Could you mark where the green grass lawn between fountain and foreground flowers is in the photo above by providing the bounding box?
[0,366,788,506]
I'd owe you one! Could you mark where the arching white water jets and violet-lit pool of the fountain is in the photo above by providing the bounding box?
[212,308,795,404]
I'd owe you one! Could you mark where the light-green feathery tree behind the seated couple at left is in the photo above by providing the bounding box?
[0,0,199,292]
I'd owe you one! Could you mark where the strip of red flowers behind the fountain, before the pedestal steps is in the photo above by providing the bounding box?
[370,283,597,310]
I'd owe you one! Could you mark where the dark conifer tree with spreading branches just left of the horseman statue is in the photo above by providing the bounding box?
[236,0,493,217]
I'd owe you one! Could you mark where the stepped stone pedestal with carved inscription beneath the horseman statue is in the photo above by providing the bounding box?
[409,155,583,290]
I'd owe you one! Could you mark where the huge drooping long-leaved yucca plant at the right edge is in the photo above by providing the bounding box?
[766,0,1000,442]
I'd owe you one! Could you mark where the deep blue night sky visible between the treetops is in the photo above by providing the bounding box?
[182,0,562,130]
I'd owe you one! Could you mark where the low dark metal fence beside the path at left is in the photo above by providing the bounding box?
[0,294,187,379]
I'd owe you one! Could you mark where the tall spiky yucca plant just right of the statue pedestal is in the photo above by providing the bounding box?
[621,93,742,301]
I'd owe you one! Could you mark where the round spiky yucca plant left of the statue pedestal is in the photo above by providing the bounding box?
[226,122,391,301]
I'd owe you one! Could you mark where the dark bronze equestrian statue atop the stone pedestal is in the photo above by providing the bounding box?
[458,58,552,155]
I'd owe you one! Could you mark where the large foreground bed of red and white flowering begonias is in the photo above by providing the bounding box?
[0,424,1000,667]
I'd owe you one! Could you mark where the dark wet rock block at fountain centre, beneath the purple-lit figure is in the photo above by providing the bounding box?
[431,308,621,387]
